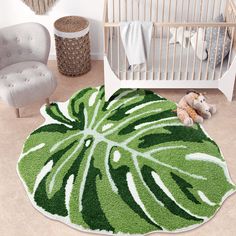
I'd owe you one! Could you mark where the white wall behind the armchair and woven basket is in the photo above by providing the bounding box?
[0,0,103,59]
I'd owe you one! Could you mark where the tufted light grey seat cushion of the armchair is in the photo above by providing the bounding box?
[0,61,57,108]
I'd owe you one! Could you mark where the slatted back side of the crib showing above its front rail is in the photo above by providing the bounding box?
[106,0,232,23]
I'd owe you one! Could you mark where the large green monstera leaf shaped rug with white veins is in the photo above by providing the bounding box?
[18,87,235,235]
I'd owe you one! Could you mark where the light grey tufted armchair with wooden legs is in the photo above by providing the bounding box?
[0,23,57,117]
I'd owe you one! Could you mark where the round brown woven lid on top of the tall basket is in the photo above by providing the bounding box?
[54,16,89,33]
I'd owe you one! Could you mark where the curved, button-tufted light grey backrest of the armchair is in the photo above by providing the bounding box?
[0,23,51,69]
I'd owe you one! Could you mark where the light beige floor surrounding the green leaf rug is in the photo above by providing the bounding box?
[0,61,236,236]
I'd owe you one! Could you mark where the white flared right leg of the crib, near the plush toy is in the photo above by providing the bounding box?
[218,57,236,102]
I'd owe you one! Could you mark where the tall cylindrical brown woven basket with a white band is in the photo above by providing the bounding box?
[54,16,91,76]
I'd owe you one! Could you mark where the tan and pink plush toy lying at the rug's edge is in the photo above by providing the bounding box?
[177,91,216,126]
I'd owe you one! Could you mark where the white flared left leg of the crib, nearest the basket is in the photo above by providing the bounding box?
[104,56,120,101]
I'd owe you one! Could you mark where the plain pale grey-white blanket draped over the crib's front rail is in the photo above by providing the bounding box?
[120,21,153,65]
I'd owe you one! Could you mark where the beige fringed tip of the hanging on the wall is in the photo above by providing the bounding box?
[22,0,56,15]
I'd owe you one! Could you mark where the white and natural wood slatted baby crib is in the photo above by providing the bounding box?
[104,0,236,101]
